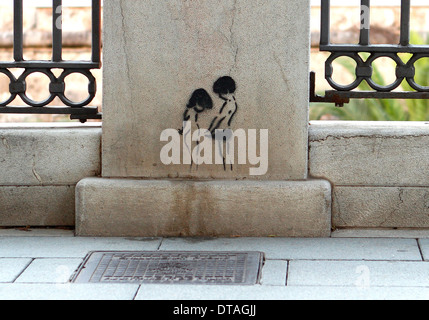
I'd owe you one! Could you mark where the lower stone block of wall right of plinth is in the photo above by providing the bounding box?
[332,186,429,228]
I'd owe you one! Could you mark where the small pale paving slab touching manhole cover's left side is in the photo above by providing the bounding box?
[15,258,83,283]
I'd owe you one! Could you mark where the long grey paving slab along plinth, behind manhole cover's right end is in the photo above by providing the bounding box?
[160,238,420,261]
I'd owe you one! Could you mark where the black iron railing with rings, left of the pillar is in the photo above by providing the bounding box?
[0,0,101,122]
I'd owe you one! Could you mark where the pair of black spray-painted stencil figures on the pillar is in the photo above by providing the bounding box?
[179,76,238,170]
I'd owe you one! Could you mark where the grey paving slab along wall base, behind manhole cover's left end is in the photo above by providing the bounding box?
[0,237,161,258]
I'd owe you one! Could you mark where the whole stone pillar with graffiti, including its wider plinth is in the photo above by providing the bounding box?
[76,0,330,236]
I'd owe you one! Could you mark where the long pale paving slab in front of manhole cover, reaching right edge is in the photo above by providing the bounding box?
[135,285,429,300]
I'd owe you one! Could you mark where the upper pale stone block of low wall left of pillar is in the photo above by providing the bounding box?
[0,124,101,186]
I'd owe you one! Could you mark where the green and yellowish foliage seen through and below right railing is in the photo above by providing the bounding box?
[310,33,429,121]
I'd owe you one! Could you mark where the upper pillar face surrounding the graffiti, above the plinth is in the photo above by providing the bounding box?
[102,0,310,180]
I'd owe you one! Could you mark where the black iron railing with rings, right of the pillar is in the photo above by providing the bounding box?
[310,0,429,106]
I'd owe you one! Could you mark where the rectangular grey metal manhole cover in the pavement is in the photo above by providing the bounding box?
[71,251,264,285]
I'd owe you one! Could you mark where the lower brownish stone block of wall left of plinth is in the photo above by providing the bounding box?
[0,186,75,227]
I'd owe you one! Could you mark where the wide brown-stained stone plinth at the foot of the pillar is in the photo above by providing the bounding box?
[76,178,331,237]
